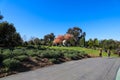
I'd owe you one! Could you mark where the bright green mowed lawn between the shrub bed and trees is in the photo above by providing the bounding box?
[50,46,118,57]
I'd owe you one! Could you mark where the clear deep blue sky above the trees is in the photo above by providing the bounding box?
[0,0,120,40]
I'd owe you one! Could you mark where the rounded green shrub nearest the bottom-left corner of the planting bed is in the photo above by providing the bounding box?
[3,58,20,70]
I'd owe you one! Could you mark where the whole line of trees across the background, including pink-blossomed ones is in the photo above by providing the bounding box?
[0,15,120,50]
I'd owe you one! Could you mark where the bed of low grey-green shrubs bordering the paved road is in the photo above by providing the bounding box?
[0,47,88,75]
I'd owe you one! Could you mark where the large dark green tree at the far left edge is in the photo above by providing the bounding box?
[0,22,23,47]
